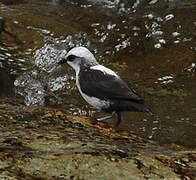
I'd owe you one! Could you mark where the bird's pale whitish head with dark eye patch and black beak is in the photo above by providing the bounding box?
[58,47,98,72]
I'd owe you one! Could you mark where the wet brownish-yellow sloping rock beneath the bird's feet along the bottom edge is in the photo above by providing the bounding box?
[0,99,195,180]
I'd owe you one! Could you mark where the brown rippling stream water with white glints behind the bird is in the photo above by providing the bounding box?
[0,0,196,147]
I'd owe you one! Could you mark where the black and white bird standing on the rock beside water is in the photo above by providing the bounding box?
[58,46,153,124]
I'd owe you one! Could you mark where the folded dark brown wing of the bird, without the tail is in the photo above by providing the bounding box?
[79,68,143,103]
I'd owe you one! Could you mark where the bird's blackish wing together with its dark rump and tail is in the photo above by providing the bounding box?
[79,66,153,115]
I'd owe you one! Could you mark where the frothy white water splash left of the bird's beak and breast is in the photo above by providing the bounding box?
[14,39,67,106]
